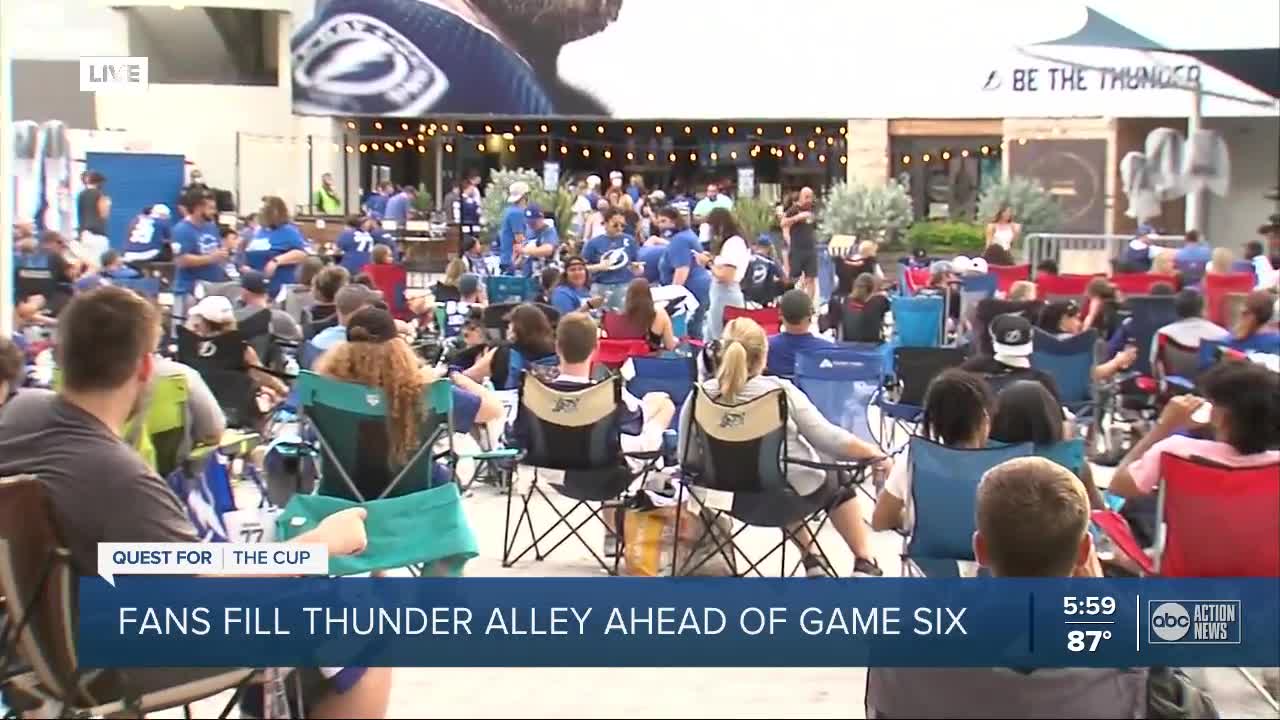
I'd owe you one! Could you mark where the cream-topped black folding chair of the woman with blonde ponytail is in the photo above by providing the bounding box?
[672,386,865,577]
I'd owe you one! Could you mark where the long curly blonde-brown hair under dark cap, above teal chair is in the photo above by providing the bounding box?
[315,338,426,465]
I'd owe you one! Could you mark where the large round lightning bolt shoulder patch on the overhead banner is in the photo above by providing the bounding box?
[293,13,449,115]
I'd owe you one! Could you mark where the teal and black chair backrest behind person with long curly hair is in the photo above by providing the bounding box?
[297,373,449,500]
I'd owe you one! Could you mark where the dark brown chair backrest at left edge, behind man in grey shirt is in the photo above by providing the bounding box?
[0,475,79,701]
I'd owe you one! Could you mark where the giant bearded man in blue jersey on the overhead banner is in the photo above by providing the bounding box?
[291,0,622,117]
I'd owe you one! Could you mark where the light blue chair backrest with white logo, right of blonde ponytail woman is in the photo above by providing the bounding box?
[795,347,884,443]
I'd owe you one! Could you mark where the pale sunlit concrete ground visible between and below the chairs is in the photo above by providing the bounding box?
[161,448,1276,719]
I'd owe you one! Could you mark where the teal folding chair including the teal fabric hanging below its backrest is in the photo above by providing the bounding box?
[276,373,494,575]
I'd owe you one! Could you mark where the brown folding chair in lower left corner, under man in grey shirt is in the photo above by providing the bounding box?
[0,475,257,717]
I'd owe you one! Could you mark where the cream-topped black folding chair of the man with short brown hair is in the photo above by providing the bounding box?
[502,373,660,575]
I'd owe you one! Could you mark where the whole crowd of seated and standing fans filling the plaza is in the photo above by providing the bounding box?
[0,159,1280,716]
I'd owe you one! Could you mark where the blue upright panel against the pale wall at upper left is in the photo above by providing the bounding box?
[84,152,184,250]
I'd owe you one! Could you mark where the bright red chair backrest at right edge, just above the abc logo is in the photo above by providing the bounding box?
[1160,452,1280,578]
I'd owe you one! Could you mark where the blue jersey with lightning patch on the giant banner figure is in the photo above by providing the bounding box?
[291,0,554,115]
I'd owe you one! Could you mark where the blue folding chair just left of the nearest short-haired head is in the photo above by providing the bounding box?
[902,437,1033,578]
